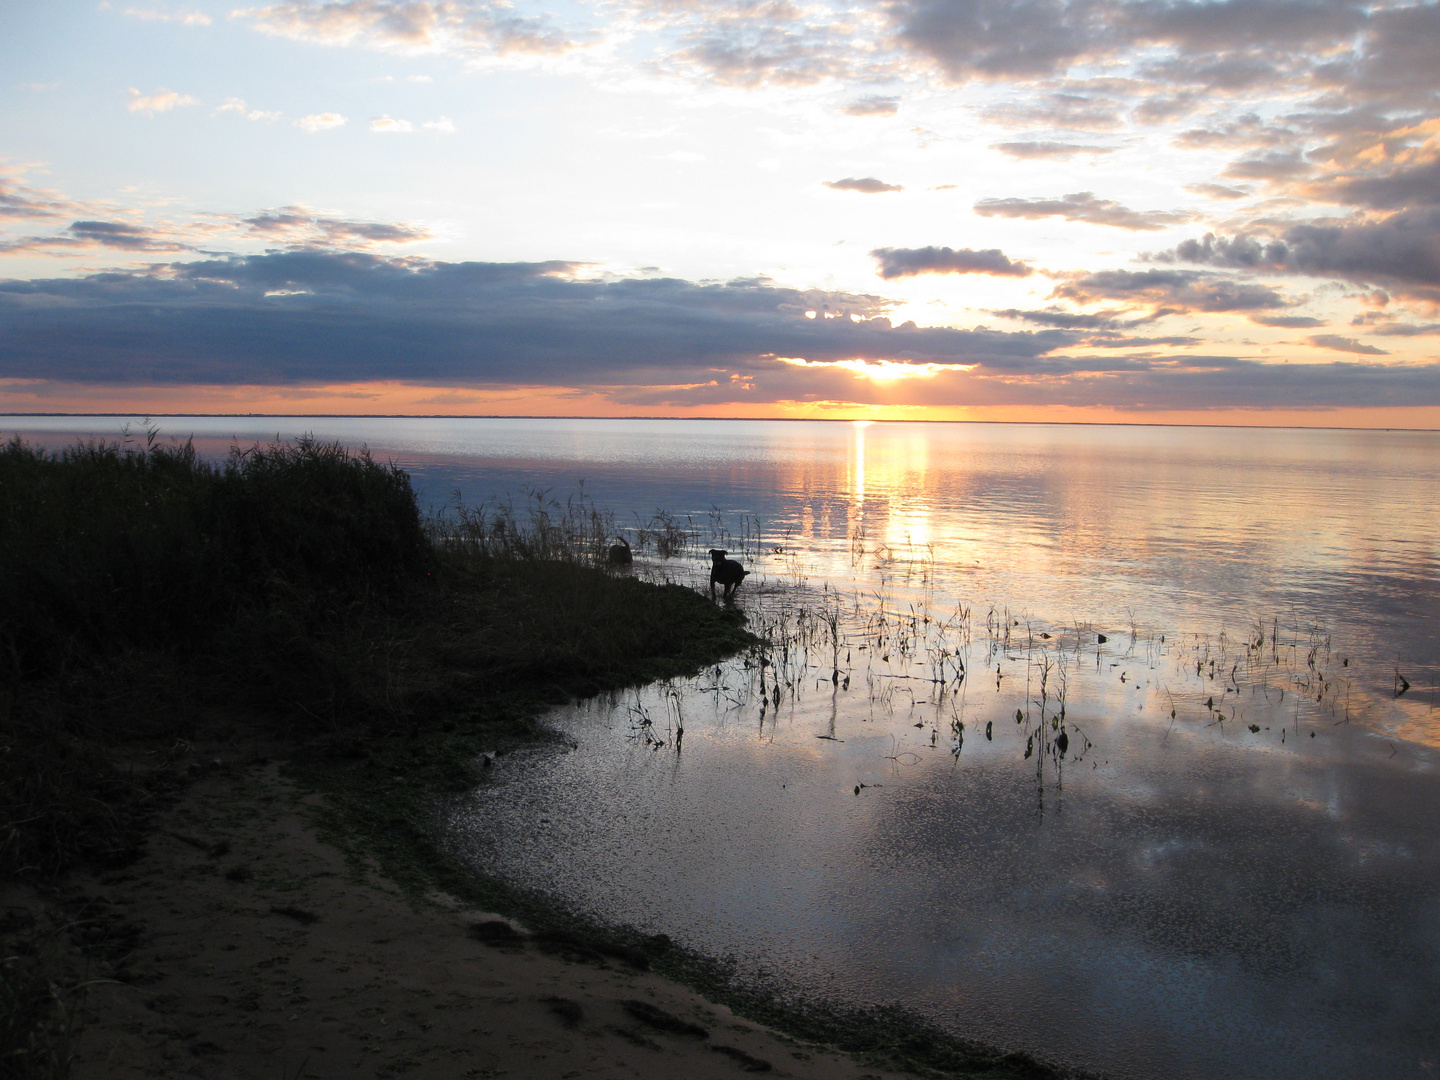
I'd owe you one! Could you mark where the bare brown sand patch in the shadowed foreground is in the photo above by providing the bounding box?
[25,762,899,1080]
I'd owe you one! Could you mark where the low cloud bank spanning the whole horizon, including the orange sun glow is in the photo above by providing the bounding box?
[0,252,1440,410]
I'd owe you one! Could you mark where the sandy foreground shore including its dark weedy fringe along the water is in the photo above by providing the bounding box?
[14,722,1089,1080]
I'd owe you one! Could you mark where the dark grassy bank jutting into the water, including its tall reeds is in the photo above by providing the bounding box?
[0,441,750,878]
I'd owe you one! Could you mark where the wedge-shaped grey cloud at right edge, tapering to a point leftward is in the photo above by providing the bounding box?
[1159,207,1440,300]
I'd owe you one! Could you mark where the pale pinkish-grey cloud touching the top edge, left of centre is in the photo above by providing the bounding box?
[232,0,577,56]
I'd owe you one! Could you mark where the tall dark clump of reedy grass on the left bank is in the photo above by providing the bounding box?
[0,439,431,680]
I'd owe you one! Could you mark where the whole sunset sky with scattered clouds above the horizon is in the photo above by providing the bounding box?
[0,0,1440,428]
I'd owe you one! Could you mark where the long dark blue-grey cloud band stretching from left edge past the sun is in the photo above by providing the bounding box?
[0,252,1074,384]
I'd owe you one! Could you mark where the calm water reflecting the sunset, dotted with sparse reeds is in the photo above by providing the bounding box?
[11,418,1440,1077]
